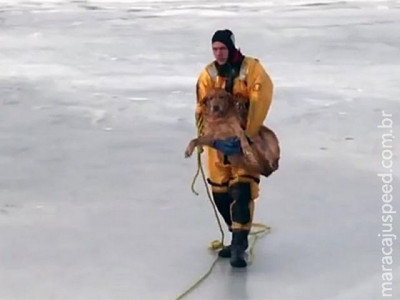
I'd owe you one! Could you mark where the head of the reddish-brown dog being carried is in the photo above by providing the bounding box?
[203,89,235,117]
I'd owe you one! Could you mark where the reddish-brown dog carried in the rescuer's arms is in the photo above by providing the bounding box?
[185,89,280,177]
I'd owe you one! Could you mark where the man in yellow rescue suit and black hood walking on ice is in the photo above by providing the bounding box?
[196,29,273,268]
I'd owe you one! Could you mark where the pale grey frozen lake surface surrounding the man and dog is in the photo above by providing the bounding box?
[0,0,400,300]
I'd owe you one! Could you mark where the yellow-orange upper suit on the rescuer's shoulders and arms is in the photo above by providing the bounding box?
[196,57,273,136]
